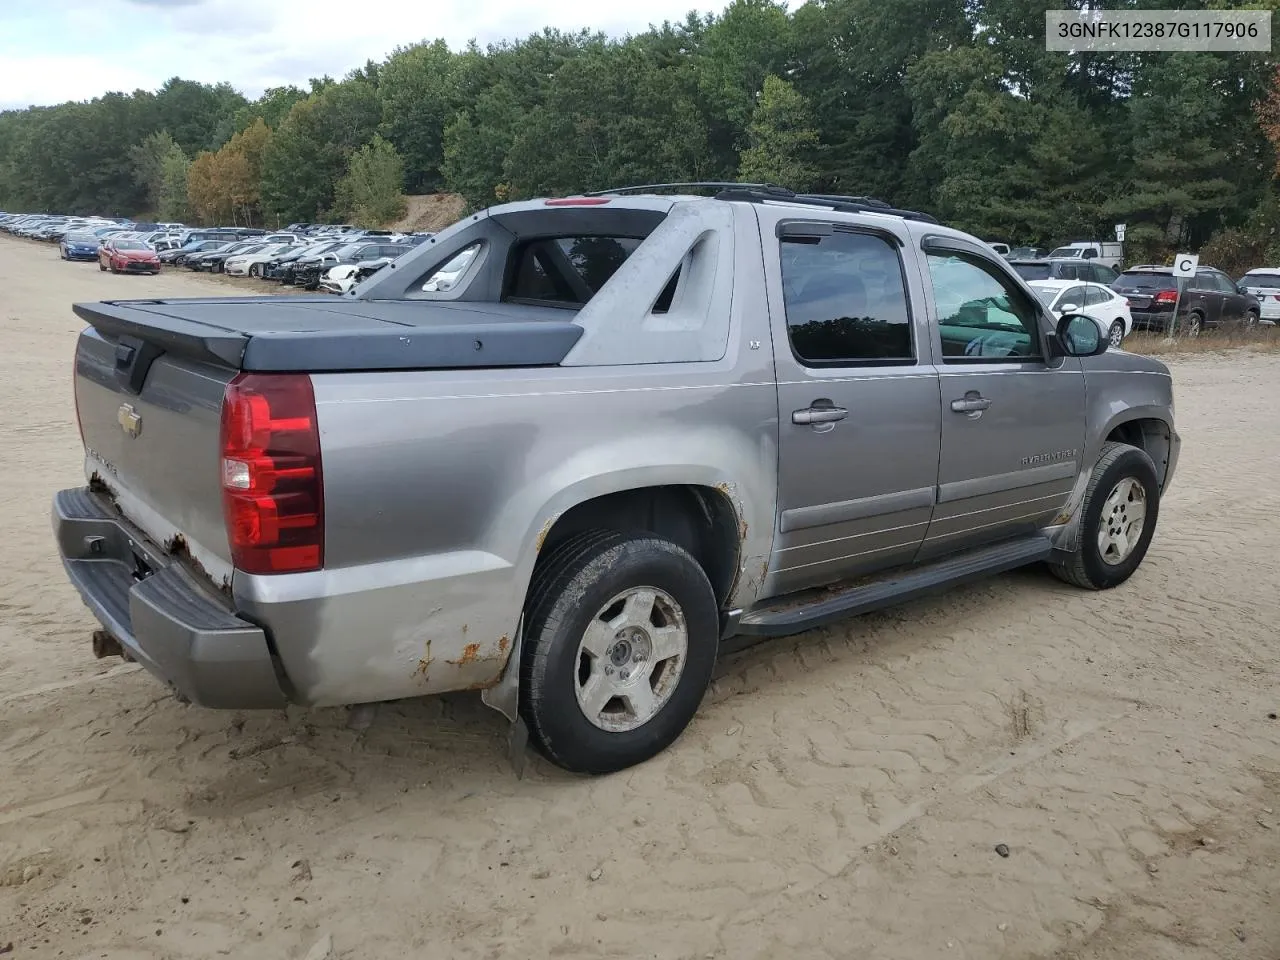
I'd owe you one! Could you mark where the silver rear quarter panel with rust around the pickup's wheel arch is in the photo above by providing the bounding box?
[233,207,778,704]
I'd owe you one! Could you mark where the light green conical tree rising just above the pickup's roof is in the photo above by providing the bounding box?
[739,74,818,189]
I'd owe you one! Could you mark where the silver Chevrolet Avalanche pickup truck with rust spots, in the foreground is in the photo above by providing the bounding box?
[52,184,1179,773]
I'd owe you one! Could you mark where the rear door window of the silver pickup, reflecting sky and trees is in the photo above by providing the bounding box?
[781,230,915,365]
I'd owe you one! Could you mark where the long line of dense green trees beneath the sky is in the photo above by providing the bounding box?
[0,0,1280,260]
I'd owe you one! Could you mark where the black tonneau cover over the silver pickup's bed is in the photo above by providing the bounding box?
[73,294,582,374]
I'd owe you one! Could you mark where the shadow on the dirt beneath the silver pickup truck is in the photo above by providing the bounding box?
[172,570,1065,818]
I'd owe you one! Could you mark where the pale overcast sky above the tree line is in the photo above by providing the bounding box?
[0,0,724,109]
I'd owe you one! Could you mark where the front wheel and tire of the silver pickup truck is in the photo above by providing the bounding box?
[1050,443,1160,590]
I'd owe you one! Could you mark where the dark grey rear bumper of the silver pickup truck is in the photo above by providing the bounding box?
[52,488,287,709]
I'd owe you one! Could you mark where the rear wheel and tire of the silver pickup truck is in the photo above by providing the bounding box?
[520,531,719,773]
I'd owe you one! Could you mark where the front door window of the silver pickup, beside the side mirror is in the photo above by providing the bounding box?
[928,253,1044,364]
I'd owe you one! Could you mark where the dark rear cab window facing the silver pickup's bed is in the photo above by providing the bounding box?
[507,237,641,306]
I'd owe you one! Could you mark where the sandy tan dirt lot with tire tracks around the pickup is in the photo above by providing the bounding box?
[0,238,1280,960]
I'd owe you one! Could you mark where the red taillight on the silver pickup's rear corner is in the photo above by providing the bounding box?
[221,374,324,573]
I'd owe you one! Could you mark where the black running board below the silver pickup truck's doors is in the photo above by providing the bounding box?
[731,534,1052,637]
